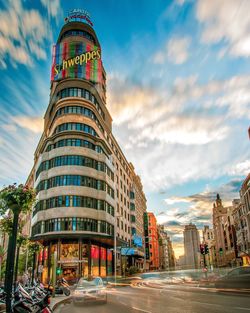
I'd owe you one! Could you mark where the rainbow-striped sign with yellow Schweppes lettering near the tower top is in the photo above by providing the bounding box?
[51,42,102,83]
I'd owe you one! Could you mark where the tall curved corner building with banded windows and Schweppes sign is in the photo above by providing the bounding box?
[29,14,146,281]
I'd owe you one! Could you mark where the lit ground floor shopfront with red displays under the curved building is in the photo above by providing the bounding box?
[37,238,113,284]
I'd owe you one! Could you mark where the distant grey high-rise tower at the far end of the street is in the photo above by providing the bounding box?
[183,223,200,269]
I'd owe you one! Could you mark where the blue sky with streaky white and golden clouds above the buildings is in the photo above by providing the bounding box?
[0,0,250,256]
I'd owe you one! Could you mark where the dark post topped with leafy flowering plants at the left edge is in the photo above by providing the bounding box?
[0,184,36,312]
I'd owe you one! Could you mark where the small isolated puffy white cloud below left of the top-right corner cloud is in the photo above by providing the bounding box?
[153,37,191,65]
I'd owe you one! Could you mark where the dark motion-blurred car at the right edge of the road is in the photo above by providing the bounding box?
[215,266,250,289]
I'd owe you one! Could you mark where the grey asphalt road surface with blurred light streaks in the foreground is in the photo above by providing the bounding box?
[55,286,250,313]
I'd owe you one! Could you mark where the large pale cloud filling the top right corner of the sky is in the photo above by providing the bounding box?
[196,0,250,57]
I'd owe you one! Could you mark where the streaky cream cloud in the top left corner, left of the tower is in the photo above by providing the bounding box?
[0,0,50,68]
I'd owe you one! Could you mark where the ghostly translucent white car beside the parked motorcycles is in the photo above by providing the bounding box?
[72,277,107,305]
